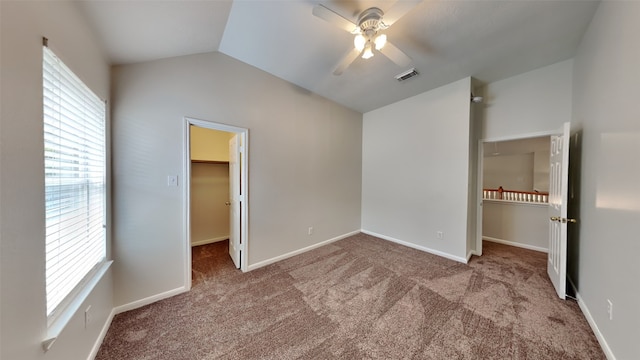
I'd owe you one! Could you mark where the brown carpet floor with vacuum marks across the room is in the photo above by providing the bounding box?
[96,234,605,360]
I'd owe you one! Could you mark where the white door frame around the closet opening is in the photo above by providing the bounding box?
[182,117,249,289]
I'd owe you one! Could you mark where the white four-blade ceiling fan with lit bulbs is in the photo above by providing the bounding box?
[312,0,422,75]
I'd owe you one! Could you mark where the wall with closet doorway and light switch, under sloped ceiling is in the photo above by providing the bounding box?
[112,53,362,305]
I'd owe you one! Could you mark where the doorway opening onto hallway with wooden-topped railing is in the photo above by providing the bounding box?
[475,132,553,255]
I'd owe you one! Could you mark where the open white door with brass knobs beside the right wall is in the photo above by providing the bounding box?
[547,123,575,299]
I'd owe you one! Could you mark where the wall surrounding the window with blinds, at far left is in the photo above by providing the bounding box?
[0,1,113,360]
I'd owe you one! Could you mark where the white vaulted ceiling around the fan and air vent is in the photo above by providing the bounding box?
[78,0,598,112]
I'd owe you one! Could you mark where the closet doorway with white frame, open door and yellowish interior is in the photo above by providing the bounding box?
[183,118,248,286]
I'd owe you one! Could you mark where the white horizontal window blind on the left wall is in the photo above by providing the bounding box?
[42,47,106,318]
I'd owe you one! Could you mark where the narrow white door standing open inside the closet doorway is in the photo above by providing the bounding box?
[229,135,242,268]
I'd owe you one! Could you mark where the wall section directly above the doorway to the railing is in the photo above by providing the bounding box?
[481,60,573,139]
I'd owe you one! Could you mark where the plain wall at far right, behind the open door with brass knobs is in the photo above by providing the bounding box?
[569,1,640,359]
